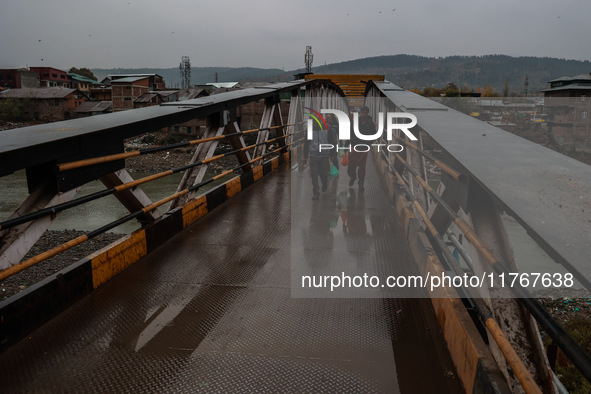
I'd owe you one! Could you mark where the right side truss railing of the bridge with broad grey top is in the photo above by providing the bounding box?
[366,82,591,392]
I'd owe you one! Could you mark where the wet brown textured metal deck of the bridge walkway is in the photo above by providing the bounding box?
[0,161,462,393]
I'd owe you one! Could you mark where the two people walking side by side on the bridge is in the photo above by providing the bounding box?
[303,107,376,200]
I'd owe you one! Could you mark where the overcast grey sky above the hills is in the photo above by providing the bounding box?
[0,0,591,71]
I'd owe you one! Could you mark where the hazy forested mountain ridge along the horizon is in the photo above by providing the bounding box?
[92,55,591,95]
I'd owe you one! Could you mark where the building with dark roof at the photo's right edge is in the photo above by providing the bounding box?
[542,74,591,152]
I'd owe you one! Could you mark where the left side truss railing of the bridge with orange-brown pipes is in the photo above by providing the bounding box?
[0,81,343,290]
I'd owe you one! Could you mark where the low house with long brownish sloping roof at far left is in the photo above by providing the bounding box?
[0,86,87,121]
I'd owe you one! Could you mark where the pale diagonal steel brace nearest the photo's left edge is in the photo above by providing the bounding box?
[0,180,80,269]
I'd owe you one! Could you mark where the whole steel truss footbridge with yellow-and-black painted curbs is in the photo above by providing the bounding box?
[0,75,591,393]
